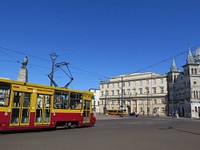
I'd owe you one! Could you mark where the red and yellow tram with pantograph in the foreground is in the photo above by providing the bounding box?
[0,78,96,131]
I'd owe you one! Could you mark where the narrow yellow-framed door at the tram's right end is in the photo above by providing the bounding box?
[83,100,91,123]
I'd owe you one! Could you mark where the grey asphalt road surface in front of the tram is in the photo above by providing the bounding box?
[0,117,200,150]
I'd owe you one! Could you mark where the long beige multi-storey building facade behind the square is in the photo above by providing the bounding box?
[99,72,168,116]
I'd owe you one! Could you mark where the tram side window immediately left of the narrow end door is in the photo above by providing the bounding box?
[70,93,83,109]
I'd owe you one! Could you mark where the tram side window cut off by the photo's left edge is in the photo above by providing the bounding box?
[0,83,10,106]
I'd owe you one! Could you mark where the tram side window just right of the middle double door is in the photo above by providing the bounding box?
[54,91,69,109]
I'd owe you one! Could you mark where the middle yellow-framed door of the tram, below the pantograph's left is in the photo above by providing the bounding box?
[35,94,51,125]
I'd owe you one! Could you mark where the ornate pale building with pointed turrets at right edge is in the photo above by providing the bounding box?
[167,47,200,118]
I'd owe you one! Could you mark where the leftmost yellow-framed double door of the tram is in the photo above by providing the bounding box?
[10,91,31,126]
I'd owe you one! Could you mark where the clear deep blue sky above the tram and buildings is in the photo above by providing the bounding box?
[0,0,200,90]
